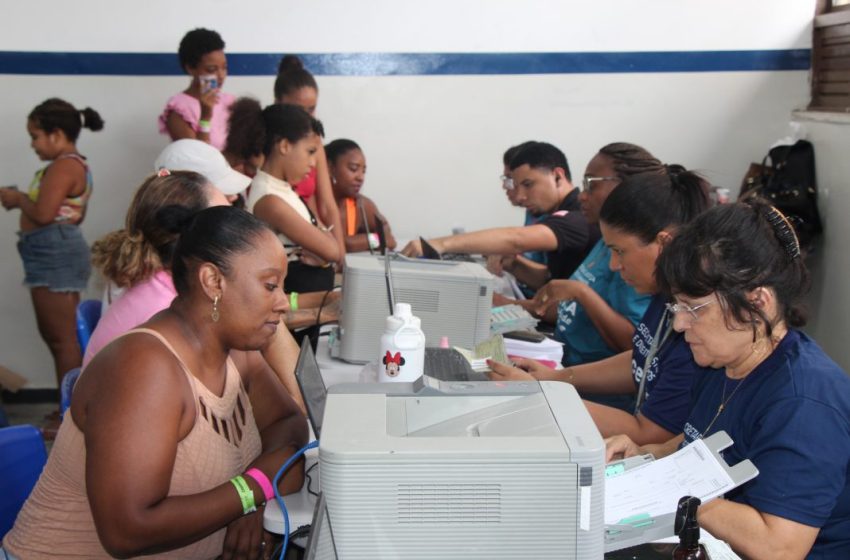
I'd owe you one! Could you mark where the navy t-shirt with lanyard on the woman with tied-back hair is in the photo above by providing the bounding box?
[632,295,718,434]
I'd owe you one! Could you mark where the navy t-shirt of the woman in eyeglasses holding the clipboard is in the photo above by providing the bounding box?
[684,330,850,559]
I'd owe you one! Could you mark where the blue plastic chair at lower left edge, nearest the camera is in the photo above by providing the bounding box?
[0,424,47,540]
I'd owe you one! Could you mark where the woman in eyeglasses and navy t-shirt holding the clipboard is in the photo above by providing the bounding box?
[608,201,850,559]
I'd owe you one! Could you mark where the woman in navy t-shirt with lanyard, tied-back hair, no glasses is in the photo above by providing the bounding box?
[491,166,710,444]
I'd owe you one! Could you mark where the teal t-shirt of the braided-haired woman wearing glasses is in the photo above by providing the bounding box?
[555,239,652,366]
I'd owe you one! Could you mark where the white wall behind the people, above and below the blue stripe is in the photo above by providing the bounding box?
[0,0,814,387]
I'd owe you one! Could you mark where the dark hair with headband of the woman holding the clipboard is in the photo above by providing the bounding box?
[656,199,809,342]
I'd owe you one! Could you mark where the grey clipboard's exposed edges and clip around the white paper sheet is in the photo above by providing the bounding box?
[604,430,758,552]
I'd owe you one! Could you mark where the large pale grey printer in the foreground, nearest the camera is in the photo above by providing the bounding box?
[319,376,605,560]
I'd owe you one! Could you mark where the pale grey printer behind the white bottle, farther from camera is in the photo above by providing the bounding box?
[338,254,493,363]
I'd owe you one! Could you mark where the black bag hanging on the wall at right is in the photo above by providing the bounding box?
[738,140,823,248]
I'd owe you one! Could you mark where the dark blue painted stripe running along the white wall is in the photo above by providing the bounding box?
[0,49,811,76]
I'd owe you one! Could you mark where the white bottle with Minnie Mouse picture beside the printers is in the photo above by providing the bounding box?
[378,303,425,381]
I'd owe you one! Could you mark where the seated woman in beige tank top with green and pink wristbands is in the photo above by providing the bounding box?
[3,206,307,560]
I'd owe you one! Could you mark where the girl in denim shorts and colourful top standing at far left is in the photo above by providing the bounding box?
[0,98,103,390]
